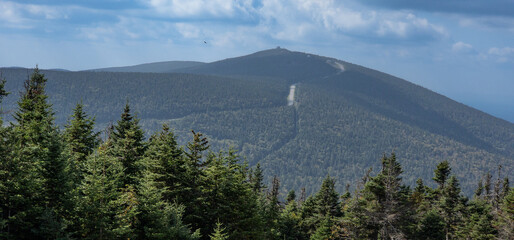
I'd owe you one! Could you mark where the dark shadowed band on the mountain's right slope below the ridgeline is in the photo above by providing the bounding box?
[316,71,498,153]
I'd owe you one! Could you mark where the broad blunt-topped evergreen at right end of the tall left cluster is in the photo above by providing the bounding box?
[202,150,262,239]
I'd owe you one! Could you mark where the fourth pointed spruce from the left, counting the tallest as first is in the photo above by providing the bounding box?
[137,125,199,239]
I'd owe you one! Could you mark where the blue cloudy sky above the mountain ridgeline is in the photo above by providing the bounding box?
[0,0,514,122]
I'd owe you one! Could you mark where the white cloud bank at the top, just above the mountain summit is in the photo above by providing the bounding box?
[257,0,447,41]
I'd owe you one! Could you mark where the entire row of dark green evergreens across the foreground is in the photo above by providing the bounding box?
[0,68,514,239]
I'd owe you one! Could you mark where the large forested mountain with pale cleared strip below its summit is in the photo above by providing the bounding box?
[1,48,514,194]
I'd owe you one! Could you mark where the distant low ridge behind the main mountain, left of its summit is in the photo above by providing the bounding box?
[87,61,205,73]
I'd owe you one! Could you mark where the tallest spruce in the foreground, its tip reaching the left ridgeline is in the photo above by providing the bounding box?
[4,67,69,239]
